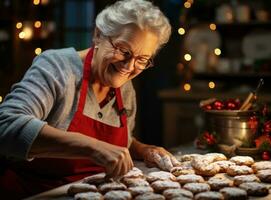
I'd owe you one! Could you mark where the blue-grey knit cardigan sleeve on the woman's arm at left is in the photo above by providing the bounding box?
[0,50,70,159]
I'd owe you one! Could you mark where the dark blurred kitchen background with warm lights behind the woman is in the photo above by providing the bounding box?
[0,0,271,147]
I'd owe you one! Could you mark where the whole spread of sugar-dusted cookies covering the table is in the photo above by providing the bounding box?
[67,153,271,200]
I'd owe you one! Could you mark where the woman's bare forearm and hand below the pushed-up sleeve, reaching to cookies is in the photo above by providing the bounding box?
[28,125,133,177]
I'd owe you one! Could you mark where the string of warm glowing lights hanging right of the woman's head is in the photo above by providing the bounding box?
[178,0,221,92]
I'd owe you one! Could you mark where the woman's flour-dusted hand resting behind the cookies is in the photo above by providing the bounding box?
[142,145,180,171]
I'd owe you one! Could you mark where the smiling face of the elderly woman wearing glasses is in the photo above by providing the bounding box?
[92,27,158,88]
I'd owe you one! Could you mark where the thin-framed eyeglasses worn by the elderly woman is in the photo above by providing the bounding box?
[108,37,153,70]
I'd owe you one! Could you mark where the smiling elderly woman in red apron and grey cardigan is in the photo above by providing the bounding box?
[0,0,178,197]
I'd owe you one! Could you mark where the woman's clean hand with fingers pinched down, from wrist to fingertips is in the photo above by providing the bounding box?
[91,141,134,177]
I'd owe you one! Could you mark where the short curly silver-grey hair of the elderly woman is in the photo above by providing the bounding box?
[96,0,171,47]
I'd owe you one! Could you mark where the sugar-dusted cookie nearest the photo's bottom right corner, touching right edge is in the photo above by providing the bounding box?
[239,182,269,196]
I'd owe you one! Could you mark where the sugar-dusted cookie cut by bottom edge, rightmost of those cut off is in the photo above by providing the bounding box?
[219,187,247,200]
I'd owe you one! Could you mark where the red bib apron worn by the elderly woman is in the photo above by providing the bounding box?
[0,49,128,199]
